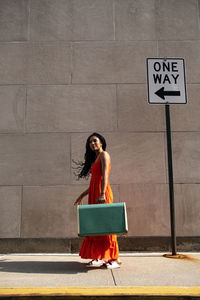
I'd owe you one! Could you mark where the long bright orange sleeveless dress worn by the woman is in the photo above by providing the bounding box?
[79,158,119,260]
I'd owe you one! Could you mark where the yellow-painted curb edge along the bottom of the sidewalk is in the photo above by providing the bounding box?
[0,286,200,299]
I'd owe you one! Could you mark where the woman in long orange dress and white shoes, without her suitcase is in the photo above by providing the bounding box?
[74,132,120,269]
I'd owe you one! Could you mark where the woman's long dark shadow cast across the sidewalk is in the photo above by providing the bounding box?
[0,261,95,274]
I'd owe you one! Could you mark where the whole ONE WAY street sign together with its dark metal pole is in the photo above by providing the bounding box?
[146,57,187,258]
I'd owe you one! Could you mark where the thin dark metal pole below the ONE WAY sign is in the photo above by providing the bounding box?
[165,104,176,255]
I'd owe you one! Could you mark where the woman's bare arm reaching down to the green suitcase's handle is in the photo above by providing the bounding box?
[97,151,110,203]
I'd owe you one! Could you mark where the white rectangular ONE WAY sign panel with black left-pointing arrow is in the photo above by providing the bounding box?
[147,58,187,104]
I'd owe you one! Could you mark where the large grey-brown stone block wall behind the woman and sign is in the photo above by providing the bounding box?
[0,0,200,252]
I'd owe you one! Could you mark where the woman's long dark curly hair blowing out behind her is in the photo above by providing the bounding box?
[73,132,106,179]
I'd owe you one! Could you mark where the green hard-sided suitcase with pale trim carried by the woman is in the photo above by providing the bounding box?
[77,202,128,236]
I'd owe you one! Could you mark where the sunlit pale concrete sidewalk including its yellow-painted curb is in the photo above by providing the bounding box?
[0,253,200,298]
